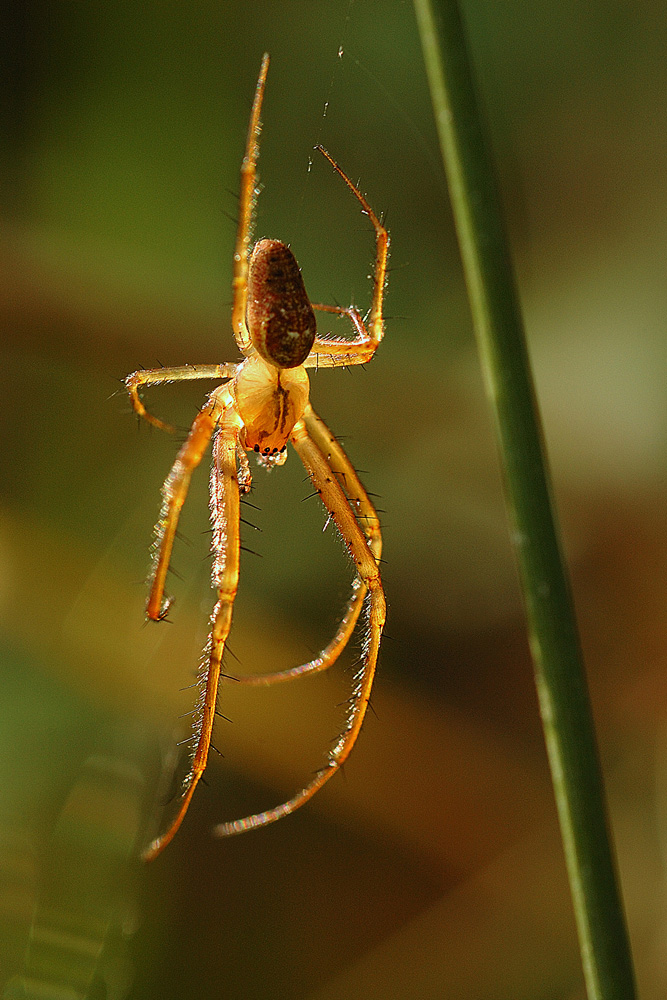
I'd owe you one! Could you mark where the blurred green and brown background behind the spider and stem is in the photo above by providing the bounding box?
[0,0,667,1000]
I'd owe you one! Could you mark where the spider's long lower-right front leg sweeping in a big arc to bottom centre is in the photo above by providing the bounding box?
[213,420,386,837]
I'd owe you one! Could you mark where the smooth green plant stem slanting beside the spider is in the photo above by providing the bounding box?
[415,0,635,1000]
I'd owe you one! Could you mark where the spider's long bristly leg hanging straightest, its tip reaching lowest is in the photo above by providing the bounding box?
[143,410,240,861]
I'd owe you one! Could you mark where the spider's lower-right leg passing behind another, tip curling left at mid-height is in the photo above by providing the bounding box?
[234,404,382,687]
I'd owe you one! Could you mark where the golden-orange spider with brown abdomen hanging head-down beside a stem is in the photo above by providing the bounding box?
[125,54,389,861]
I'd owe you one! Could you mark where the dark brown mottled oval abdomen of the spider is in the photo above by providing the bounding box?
[247,240,316,368]
